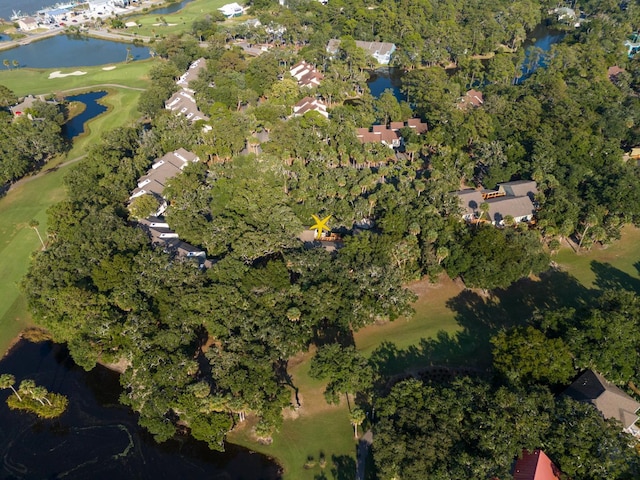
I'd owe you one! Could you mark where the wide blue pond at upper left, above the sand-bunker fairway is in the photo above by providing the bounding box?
[0,35,151,68]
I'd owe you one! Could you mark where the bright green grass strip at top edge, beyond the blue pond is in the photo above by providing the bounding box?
[125,0,229,38]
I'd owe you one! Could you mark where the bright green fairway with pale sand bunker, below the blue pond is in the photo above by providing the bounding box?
[0,59,157,96]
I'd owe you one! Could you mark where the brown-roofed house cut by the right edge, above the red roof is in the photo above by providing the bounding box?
[564,370,640,437]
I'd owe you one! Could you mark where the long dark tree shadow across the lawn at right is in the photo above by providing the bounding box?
[371,270,593,380]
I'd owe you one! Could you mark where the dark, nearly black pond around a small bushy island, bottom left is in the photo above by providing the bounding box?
[0,341,279,480]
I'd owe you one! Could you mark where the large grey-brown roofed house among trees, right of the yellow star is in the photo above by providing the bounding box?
[455,180,538,226]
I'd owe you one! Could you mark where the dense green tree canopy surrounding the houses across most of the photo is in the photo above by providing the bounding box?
[7,0,640,479]
